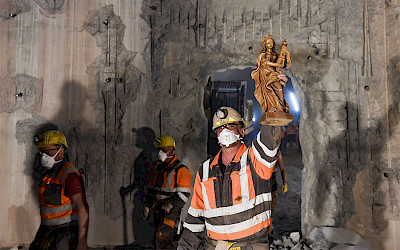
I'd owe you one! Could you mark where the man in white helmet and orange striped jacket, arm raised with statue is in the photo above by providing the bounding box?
[178,74,287,250]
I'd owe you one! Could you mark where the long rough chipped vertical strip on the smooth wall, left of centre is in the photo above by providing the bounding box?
[77,5,143,218]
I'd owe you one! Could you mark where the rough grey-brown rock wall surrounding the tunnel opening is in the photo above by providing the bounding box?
[0,0,400,249]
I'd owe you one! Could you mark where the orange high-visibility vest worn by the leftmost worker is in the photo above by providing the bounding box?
[39,162,83,226]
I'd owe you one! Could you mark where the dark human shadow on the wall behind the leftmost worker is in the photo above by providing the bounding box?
[51,81,111,216]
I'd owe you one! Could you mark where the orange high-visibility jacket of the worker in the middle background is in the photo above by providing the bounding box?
[152,155,191,203]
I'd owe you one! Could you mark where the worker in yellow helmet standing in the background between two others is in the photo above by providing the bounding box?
[143,136,191,249]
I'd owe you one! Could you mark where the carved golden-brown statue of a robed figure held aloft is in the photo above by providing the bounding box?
[251,34,293,126]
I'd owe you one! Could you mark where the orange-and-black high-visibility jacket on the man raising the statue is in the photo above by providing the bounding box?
[179,125,281,249]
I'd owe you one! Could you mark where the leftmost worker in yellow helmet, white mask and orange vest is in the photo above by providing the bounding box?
[29,130,89,250]
